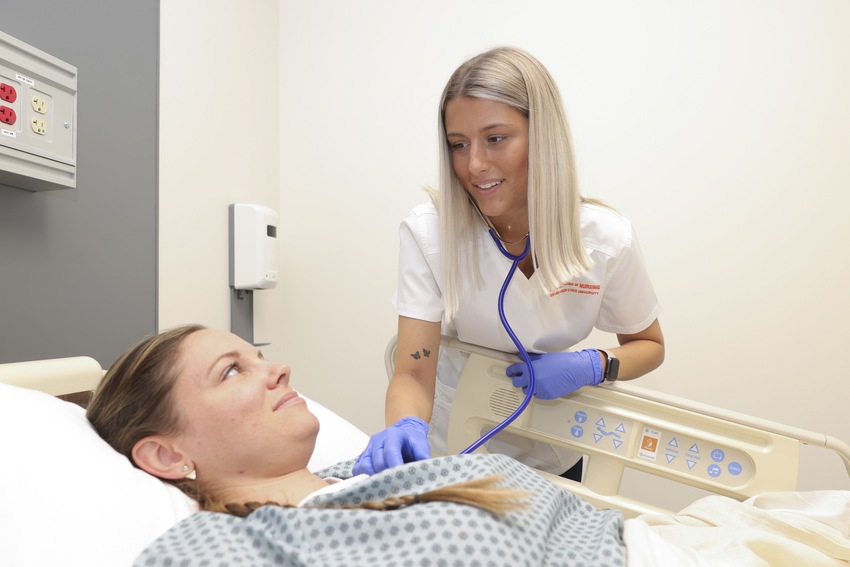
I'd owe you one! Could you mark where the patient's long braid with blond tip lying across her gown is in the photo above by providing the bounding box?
[210,475,528,517]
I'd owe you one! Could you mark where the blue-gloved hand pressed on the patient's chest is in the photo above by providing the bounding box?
[352,416,431,475]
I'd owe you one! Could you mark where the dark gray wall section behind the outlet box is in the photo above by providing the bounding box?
[0,0,159,367]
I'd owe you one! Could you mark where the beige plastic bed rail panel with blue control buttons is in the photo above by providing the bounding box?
[448,354,799,497]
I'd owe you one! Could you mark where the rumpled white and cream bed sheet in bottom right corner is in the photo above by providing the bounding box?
[623,490,850,567]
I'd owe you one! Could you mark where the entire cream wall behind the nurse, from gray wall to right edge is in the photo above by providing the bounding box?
[159,0,850,506]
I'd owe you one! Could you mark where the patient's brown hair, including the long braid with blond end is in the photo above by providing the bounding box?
[86,325,527,516]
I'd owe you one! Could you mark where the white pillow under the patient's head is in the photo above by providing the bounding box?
[0,384,368,567]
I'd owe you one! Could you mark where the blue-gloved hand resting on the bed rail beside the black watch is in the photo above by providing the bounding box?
[505,349,602,400]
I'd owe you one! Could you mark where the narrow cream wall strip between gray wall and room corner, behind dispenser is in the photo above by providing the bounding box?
[159,0,282,359]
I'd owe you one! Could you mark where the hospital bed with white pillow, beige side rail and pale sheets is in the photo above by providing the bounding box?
[0,344,850,567]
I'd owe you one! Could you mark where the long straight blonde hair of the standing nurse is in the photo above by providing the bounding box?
[432,47,593,319]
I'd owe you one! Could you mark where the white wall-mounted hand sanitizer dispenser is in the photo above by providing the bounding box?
[229,203,280,289]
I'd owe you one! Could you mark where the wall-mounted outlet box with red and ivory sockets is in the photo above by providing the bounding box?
[0,32,77,191]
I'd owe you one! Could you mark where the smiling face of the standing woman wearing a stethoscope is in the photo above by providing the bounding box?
[444,97,528,230]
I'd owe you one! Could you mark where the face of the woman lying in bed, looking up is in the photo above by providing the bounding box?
[174,329,319,482]
